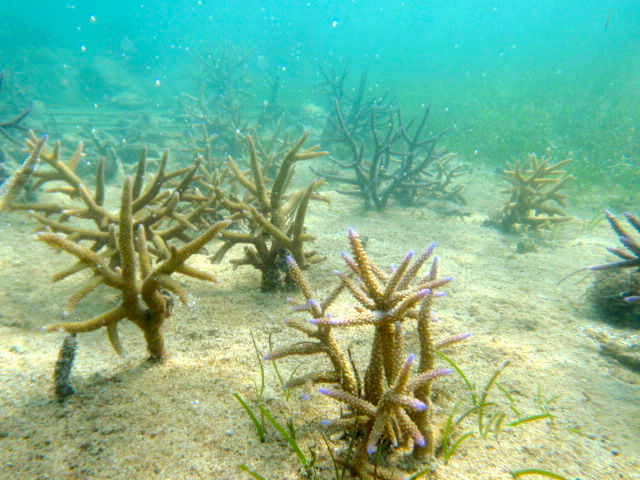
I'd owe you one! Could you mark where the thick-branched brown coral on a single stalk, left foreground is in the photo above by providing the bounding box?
[38,178,230,361]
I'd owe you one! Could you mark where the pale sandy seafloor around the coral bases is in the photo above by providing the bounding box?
[0,162,640,480]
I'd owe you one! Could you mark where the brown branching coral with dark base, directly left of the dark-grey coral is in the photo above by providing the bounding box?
[212,132,327,292]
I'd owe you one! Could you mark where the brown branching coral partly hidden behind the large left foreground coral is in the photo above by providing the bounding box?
[19,131,217,258]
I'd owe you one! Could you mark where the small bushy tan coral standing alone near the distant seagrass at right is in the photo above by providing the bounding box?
[487,149,575,231]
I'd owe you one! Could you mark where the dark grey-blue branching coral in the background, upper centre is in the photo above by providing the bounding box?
[318,68,466,211]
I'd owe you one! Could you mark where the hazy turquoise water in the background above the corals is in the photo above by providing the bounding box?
[0,0,640,185]
